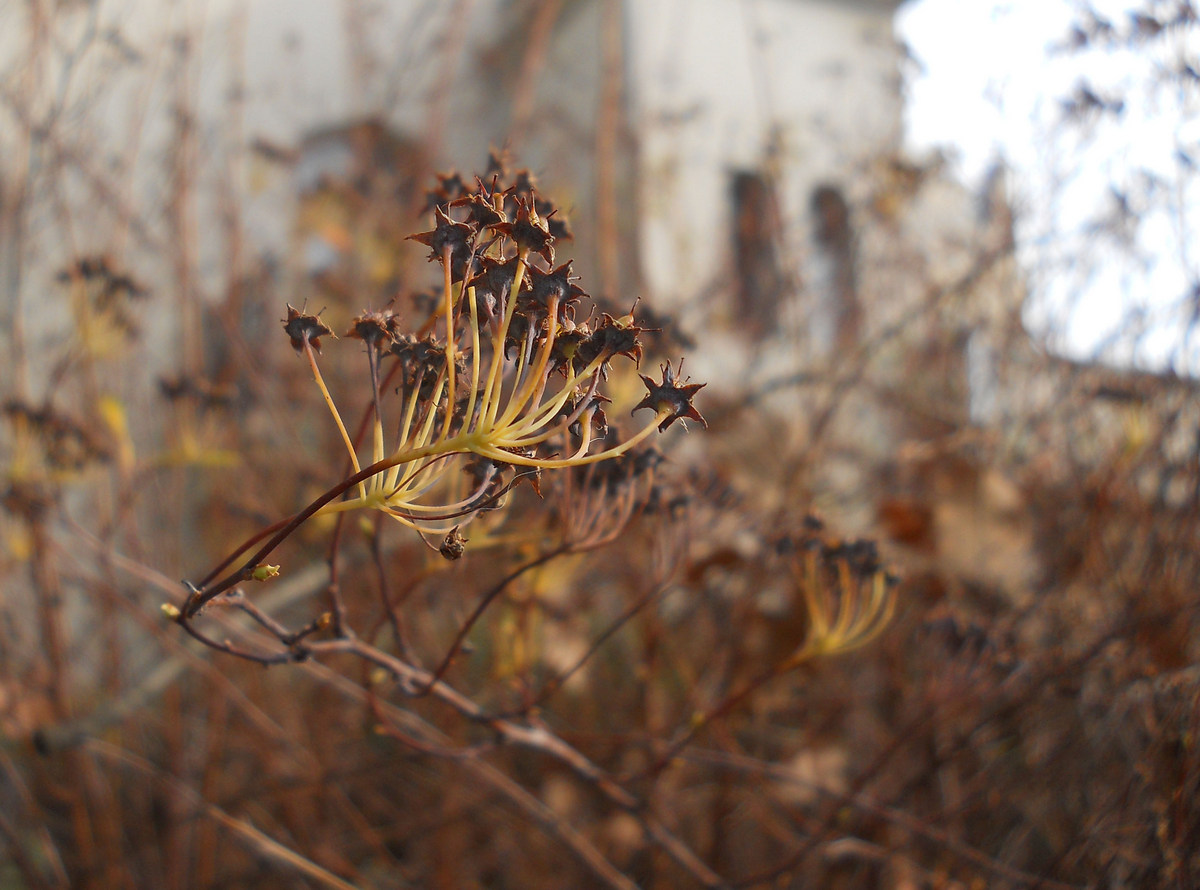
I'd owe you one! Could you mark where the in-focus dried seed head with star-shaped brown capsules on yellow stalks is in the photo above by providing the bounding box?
[168,162,704,647]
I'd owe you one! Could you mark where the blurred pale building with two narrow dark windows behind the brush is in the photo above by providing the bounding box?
[0,0,1176,599]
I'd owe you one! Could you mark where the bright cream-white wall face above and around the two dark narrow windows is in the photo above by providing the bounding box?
[626,0,901,303]
